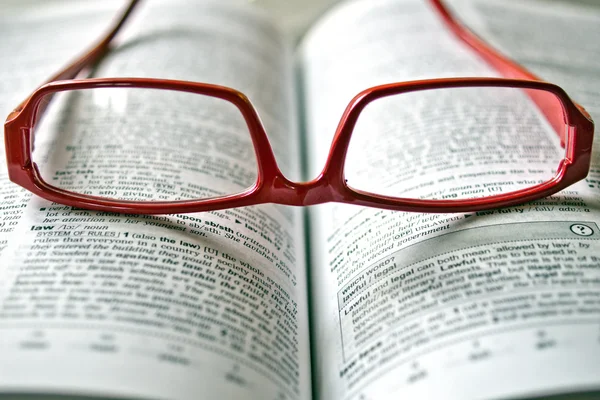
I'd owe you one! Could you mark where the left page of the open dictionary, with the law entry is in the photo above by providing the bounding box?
[0,1,310,399]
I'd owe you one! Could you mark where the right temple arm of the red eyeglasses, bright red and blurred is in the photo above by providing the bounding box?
[430,0,592,147]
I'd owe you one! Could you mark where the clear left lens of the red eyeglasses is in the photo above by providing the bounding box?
[32,87,258,201]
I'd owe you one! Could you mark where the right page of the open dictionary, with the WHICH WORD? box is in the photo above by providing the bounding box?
[299,0,600,399]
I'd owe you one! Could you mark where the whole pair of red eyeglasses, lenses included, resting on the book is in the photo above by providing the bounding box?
[4,0,594,214]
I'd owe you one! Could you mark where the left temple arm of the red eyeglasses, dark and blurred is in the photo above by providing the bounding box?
[9,0,140,121]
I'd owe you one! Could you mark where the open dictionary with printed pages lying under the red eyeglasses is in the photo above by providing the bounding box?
[0,0,600,400]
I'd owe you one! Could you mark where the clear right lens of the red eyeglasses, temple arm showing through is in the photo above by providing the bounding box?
[345,87,566,200]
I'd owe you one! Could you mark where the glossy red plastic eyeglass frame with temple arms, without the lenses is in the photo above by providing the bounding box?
[4,0,594,214]
